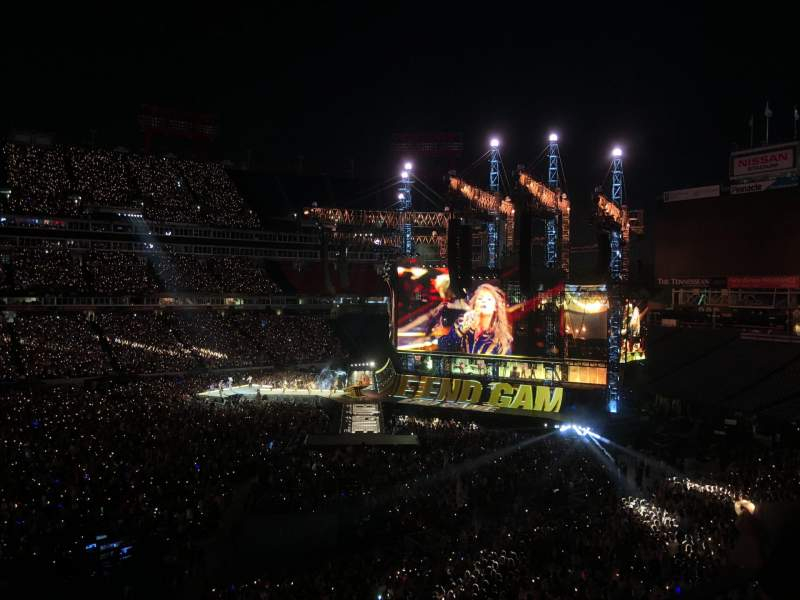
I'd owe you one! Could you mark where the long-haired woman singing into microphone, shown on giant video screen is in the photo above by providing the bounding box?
[440,283,513,354]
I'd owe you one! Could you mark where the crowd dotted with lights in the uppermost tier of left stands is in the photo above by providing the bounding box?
[2,142,260,229]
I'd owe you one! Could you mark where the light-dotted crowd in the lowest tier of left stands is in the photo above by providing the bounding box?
[0,309,344,379]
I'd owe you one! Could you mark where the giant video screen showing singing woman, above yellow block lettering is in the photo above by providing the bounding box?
[395,265,608,357]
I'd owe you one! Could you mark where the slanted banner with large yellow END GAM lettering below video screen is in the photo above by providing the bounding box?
[392,374,564,413]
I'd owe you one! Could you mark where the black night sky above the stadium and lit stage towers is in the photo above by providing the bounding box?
[0,2,800,219]
